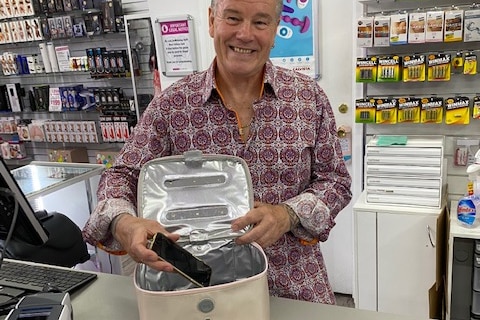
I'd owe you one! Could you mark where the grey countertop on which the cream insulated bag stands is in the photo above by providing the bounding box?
[72,273,422,320]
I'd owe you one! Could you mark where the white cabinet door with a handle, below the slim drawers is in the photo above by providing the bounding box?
[377,210,437,317]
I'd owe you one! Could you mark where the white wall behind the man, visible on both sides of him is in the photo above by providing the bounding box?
[147,0,361,294]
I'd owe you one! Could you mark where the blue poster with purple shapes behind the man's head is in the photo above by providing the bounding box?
[270,0,320,79]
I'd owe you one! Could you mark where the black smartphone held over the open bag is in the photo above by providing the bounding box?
[148,233,212,287]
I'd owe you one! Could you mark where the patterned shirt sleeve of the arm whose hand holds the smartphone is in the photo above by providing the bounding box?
[83,98,171,253]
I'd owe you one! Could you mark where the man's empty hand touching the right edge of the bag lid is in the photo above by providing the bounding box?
[232,202,290,248]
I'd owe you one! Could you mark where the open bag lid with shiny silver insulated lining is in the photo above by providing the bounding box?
[138,150,253,244]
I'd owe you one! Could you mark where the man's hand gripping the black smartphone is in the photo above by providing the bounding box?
[113,214,179,272]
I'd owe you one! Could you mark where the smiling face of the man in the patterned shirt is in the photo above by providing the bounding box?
[209,0,279,77]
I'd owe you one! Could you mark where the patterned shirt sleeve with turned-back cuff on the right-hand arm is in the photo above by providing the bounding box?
[285,86,352,242]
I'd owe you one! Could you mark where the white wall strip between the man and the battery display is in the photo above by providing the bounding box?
[319,0,361,294]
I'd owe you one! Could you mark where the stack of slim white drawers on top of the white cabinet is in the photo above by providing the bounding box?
[364,136,446,208]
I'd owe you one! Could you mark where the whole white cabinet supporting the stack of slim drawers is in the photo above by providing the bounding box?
[354,193,444,319]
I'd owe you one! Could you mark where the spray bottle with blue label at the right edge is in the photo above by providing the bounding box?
[457,150,480,227]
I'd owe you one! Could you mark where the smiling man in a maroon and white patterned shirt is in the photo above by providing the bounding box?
[83,0,351,304]
